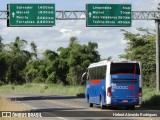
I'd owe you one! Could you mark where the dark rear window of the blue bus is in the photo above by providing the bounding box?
[110,63,140,75]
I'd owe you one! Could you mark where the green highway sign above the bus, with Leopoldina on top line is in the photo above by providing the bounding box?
[86,4,132,27]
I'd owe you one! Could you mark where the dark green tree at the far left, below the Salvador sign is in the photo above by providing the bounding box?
[0,37,31,84]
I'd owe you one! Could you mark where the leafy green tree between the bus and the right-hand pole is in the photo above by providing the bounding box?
[120,28,156,87]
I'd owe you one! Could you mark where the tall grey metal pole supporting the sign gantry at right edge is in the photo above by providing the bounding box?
[156,20,160,91]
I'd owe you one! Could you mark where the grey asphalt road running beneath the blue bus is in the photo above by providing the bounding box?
[2,94,160,120]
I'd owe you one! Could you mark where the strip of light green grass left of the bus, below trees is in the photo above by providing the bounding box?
[0,83,85,95]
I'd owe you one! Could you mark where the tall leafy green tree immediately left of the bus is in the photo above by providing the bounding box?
[63,37,100,85]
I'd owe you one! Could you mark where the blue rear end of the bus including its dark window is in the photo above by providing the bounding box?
[110,63,141,105]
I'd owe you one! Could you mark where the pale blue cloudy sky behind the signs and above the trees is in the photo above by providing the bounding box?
[0,0,160,60]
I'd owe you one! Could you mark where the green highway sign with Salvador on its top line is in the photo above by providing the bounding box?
[8,4,55,27]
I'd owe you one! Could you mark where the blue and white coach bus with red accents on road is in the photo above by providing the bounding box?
[82,60,142,110]
